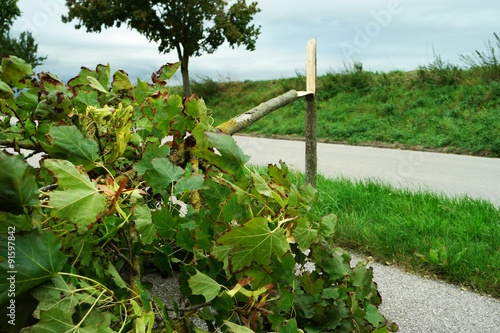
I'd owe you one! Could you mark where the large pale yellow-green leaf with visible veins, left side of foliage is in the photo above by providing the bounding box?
[44,159,106,234]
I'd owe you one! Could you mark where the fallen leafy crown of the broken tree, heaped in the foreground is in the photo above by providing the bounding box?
[0,57,397,333]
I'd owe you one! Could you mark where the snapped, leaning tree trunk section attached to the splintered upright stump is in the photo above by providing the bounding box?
[217,90,309,135]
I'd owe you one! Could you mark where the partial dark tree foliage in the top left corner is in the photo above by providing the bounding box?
[0,0,47,68]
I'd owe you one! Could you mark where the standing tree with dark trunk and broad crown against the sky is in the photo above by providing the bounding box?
[62,0,260,96]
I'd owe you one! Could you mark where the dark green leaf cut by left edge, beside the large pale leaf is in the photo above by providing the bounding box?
[0,151,40,214]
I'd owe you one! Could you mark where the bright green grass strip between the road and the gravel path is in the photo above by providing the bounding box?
[302,177,500,298]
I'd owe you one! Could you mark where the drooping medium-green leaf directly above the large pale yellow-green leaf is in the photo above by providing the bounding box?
[42,126,99,171]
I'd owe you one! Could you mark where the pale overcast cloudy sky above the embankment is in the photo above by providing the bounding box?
[12,0,500,83]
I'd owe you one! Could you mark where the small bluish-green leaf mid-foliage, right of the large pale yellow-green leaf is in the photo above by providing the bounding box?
[144,158,184,193]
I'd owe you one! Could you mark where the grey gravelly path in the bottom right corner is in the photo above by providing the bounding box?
[353,255,500,333]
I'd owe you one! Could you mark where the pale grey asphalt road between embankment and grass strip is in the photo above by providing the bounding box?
[234,136,500,207]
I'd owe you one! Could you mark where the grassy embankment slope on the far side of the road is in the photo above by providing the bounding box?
[193,65,500,157]
